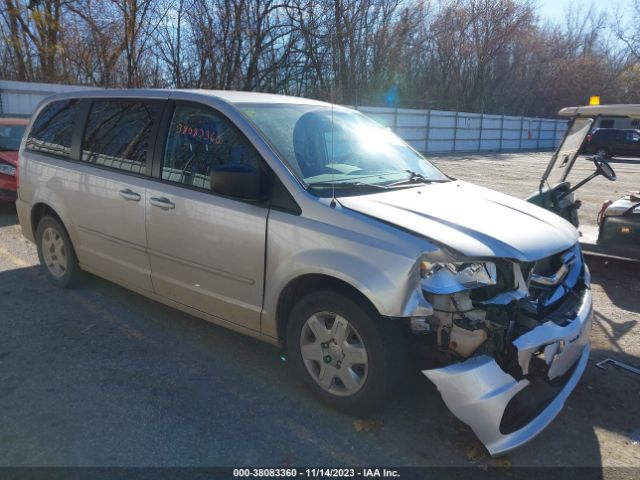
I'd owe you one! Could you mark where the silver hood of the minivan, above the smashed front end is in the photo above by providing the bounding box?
[339,180,578,261]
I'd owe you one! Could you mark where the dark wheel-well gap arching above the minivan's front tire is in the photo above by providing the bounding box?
[276,274,378,342]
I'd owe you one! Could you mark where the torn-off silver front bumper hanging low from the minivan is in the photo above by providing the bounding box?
[422,289,593,455]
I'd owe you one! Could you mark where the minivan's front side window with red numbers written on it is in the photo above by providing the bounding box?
[162,105,260,190]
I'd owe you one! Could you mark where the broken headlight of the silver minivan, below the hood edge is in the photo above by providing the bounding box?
[420,261,497,295]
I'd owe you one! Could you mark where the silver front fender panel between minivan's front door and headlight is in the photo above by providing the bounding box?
[262,212,431,337]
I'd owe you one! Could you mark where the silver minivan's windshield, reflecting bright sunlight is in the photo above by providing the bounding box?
[239,104,449,195]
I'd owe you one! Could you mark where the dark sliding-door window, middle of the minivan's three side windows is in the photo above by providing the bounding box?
[82,100,162,173]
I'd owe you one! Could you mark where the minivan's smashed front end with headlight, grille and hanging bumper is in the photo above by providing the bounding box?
[413,244,592,455]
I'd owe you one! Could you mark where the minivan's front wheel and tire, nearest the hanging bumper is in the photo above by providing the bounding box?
[286,291,407,414]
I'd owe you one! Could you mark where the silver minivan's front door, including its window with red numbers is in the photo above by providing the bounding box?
[146,103,268,330]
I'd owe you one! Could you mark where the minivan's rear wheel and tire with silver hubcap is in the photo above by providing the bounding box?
[36,216,82,288]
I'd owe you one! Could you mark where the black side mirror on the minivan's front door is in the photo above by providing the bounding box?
[211,164,263,201]
